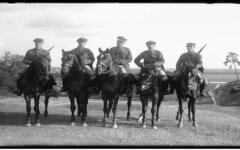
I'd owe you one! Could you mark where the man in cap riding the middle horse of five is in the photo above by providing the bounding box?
[110,36,133,95]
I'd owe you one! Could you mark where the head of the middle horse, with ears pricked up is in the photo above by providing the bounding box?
[97,48,113,75]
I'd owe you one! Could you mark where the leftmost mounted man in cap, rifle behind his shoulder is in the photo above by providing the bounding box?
[14,38,57,96]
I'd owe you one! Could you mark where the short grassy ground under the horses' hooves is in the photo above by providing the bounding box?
[0,98,240,146]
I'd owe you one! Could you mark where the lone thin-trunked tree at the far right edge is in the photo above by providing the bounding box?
[224,52,240,82]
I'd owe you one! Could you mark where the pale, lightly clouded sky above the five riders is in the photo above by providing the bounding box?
[0,3,240,69]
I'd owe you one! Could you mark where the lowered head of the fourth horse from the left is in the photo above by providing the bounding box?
[140,69,155,91]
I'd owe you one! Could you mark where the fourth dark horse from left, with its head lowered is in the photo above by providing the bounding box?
[139,68,159,130]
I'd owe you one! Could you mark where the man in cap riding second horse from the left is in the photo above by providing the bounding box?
[62,37,97,93]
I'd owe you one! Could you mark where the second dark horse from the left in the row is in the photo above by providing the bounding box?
[61,50,90,127]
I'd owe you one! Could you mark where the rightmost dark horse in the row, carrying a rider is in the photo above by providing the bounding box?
[174,65,198,128]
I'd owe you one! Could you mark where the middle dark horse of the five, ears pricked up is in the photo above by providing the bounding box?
[96,48,137,128]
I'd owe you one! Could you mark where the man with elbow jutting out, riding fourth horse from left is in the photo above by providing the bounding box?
[134,41,168,93]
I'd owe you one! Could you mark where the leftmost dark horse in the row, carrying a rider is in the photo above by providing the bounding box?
[20,56,50,126]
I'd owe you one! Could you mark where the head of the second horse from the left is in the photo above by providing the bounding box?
[61,50,78,76]
